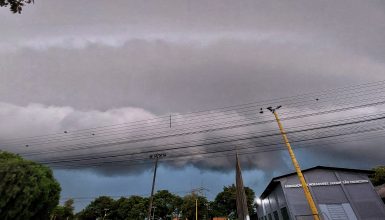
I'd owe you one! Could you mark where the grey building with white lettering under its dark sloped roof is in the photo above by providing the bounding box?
[257,166,385,220]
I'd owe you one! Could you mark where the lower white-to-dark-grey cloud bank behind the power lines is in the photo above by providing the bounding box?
[0,103,385,179]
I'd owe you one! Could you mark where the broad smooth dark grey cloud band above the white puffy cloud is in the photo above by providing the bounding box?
[0,37,385,113]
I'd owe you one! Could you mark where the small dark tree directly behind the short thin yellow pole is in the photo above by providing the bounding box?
[181,195,209,219]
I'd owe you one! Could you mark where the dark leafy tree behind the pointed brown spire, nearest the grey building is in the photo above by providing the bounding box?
[212,184,255,216]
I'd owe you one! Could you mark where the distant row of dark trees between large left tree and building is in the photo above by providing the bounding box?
[52,185,255,220]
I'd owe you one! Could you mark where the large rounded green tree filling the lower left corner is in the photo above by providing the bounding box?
[0,151,61,220]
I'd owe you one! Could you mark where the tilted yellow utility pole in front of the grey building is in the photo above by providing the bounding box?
[260,106,320,220]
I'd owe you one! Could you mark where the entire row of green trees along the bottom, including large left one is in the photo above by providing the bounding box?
[0,151,255,220]
